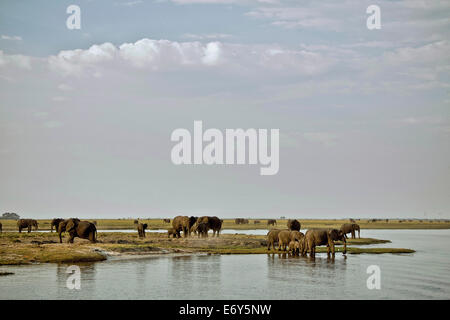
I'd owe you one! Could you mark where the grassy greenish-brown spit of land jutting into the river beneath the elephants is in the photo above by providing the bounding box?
[0,231,414,265]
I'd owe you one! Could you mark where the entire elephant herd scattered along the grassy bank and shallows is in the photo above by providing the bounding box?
[0,216,361,257]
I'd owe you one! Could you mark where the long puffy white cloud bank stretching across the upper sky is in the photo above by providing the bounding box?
[48,39,335,75]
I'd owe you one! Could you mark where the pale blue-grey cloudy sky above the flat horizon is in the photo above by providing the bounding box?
[0,0,450,218]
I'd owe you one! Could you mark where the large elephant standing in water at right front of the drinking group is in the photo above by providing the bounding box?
[303,229,347,258]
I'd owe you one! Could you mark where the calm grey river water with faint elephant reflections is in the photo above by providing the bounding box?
[0,230,450,300]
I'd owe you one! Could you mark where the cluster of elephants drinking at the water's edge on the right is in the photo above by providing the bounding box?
[267,220,360,258]
